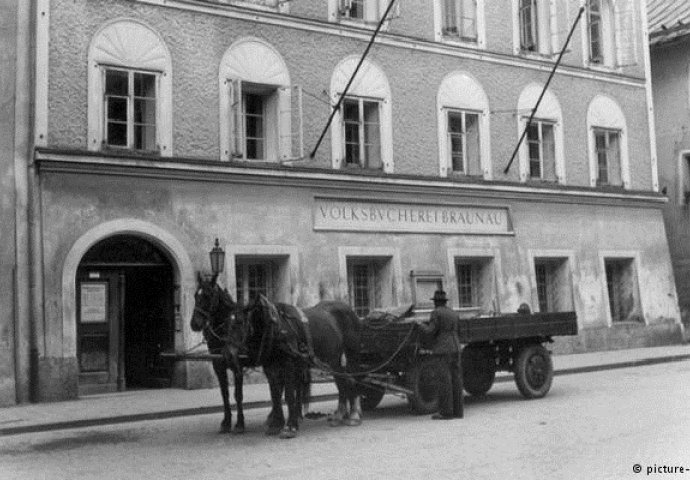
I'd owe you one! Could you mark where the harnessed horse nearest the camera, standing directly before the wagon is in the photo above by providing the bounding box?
[229,294,362,438]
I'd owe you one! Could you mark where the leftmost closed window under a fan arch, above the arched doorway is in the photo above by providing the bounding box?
[104,68,157,150]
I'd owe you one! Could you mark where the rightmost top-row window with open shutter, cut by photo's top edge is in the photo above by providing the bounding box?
[587,0,637,67]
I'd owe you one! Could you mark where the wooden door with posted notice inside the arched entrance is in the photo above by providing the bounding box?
[77,269,125,393]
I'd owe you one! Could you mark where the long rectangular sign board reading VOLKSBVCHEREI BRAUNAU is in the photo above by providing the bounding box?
[314,197,513,235]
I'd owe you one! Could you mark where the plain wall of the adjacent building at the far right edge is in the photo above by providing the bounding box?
[651,38,690,325]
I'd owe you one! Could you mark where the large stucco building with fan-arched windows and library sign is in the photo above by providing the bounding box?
[2,0,681,400]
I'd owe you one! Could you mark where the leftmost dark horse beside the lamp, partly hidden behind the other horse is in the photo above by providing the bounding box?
[191,275,309,435]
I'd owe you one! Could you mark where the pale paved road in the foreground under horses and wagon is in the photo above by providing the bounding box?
[0,361,690,480]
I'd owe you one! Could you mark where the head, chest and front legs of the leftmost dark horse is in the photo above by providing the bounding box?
[190,274,253,433]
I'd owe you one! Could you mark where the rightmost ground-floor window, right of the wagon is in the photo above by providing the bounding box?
[604,258,642,322]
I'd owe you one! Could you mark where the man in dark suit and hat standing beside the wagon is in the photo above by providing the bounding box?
[420,290,464,420]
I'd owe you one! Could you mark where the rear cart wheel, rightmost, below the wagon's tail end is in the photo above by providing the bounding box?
[515,345,553,398]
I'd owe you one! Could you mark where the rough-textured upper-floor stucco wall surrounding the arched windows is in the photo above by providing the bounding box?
[49,0,652,190]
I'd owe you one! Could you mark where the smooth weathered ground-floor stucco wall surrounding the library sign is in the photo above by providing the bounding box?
[43,174,678,370]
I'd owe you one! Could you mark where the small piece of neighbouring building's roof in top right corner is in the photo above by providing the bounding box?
[647,0,690,45]
